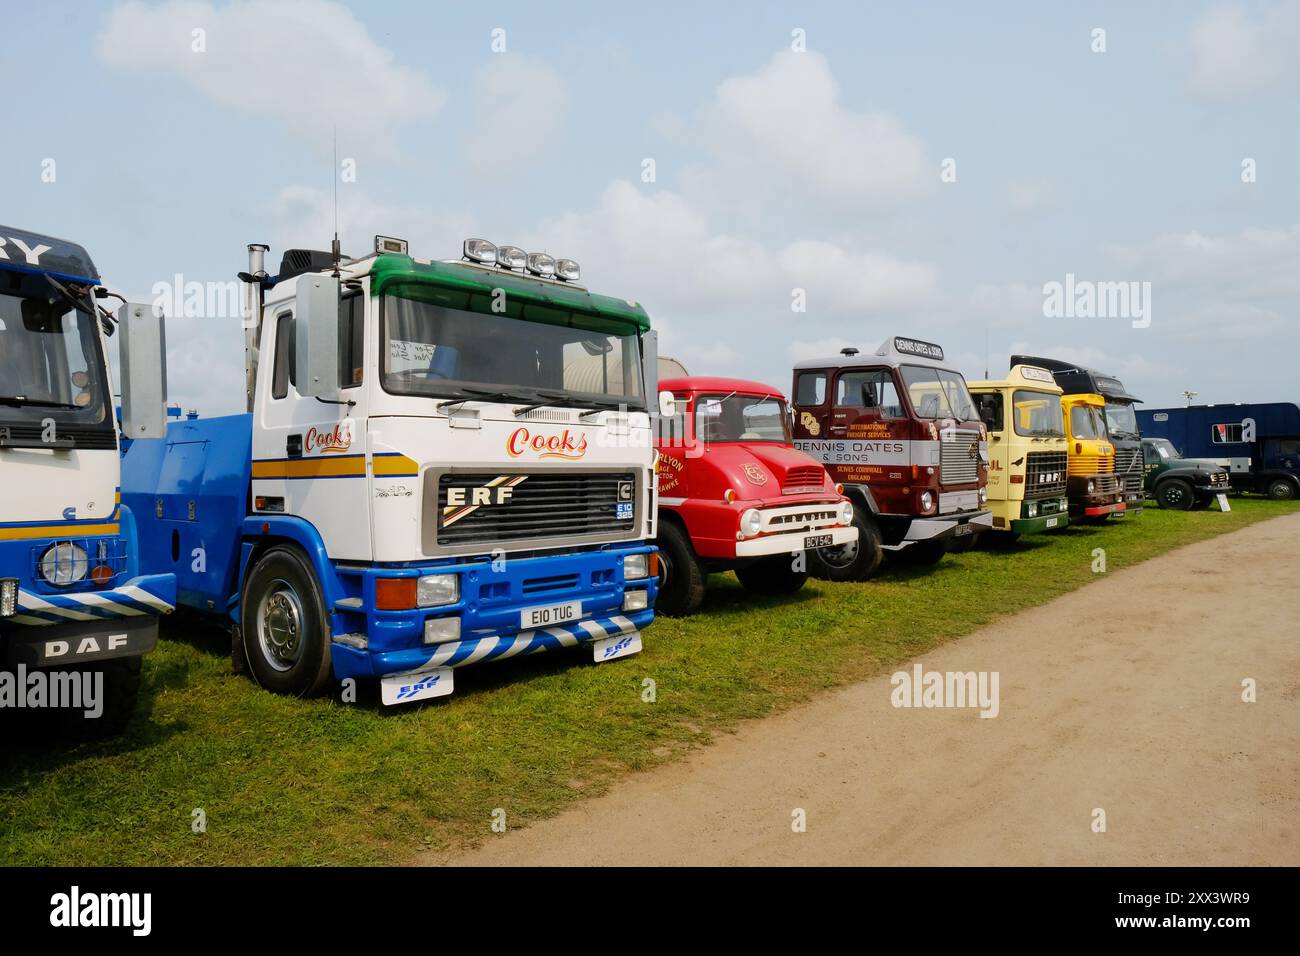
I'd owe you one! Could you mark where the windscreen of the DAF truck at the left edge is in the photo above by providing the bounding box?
[0,294,108,425]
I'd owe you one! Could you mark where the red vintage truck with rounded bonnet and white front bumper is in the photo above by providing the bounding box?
[655,376,858,615]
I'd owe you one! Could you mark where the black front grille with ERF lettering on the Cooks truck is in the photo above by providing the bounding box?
[425,472,637,548]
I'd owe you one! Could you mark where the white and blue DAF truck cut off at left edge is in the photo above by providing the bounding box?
[0,226,176,736]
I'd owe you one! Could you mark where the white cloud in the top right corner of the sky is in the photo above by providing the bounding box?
[1187,0,1300,100]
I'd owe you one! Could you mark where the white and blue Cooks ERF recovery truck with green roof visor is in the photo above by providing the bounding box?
[122,237,658,704]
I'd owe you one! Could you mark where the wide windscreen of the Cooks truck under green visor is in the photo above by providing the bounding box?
[381,295,645,408]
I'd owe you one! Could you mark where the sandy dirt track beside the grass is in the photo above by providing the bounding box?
[425,514,1300,865]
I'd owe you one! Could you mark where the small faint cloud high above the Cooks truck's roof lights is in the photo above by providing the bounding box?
[465,53,569,174]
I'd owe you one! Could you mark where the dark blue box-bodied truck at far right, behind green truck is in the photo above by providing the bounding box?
[1138,402,1300,501]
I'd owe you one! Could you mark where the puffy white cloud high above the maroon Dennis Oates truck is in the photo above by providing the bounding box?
[693,52,939,209]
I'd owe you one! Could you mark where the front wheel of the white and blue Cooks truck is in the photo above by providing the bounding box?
[239,548,330,697]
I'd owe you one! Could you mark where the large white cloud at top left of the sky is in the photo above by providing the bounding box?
[99,0,447,155]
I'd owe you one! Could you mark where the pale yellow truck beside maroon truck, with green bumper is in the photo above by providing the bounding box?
[970,365,1071,538]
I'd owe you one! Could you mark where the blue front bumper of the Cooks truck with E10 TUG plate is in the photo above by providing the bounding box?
[332,542,659,680]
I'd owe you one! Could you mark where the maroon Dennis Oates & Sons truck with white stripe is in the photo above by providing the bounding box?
[794,336,993,580]
